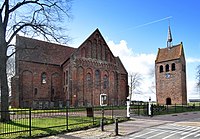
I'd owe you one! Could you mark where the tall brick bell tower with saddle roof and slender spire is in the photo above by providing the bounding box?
[155,27,187,105]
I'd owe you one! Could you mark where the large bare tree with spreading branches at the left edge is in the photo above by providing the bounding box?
[0,0,71,121]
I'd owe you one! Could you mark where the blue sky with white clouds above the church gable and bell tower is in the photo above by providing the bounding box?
[65,0,200,101]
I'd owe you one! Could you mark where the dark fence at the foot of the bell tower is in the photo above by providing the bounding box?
[130,102,200,116]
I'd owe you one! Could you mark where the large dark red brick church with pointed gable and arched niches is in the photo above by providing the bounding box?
[11,29,128,108]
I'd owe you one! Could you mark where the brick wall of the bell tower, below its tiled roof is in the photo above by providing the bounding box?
[156,59,187,104]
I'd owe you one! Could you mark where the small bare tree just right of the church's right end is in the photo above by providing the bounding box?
[129,72,142,101]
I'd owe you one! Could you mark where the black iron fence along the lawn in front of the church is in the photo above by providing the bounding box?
[0,106,126,138]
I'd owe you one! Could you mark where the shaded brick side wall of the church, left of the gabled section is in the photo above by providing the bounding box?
[13,61,65,107]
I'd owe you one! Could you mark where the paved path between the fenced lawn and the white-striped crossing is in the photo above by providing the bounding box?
[39,112,200,139]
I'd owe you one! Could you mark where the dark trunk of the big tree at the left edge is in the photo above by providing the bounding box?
[0,45,10,122]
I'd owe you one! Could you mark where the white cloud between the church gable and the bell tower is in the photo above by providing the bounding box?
[107,40,156,101]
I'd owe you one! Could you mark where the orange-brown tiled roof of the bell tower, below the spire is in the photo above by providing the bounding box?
[155,42,184,63]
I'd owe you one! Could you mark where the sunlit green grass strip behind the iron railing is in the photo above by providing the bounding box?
[0,116,125,138]
